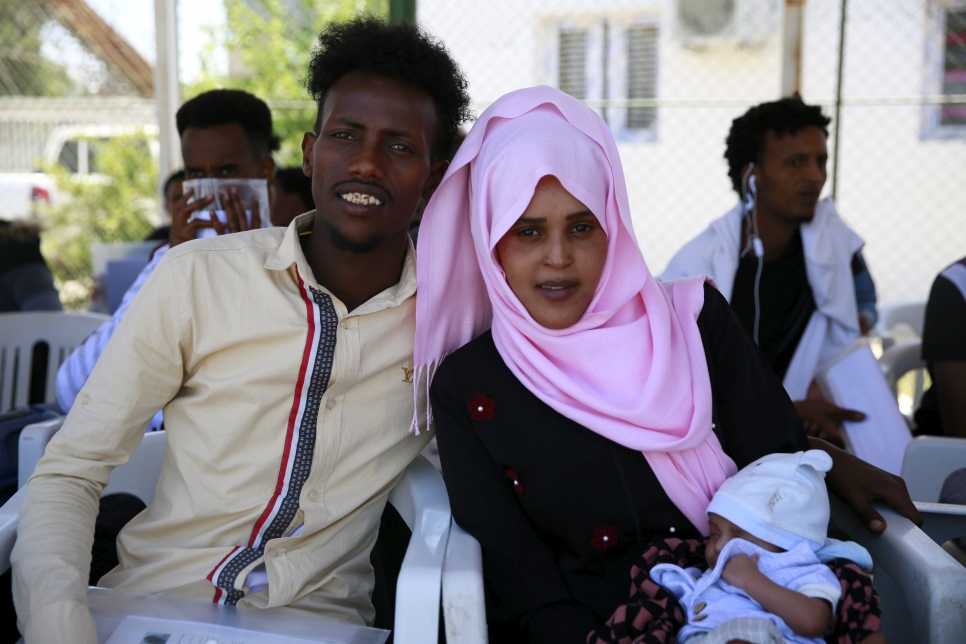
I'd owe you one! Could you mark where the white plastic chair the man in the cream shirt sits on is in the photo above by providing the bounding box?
[0,418,466,644]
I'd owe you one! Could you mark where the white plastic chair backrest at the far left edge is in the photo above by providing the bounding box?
[0,311,110,411]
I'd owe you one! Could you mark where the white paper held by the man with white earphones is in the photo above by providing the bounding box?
[816,342,912,476]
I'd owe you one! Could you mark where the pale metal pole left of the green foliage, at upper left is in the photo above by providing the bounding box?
[154,0,181,216]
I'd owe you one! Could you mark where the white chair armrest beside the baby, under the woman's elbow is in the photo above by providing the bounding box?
[829,494,966,644]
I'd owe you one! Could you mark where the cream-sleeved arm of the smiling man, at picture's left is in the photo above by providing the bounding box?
[11,254,186,643]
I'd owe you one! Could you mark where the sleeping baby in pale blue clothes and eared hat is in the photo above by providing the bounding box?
[651,450,884,644]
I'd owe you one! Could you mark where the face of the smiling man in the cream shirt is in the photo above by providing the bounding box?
[302,71,446,252]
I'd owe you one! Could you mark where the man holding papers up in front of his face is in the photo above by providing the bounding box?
[56,89,279,431]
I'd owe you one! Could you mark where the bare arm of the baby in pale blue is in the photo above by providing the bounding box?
[721,554,832,637]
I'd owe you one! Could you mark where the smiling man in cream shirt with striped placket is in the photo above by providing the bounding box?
[12,18,468,642]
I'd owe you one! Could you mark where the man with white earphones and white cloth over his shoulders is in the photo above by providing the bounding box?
[661,95,874,444]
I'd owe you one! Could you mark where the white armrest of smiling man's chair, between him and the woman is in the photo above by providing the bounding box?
[389,456,452,644]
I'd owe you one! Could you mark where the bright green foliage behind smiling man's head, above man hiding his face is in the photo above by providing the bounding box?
[185,0,388,165]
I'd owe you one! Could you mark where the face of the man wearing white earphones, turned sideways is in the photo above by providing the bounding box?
[756,126,828,223]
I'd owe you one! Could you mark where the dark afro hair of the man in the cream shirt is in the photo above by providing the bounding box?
[306,16,472,160]
